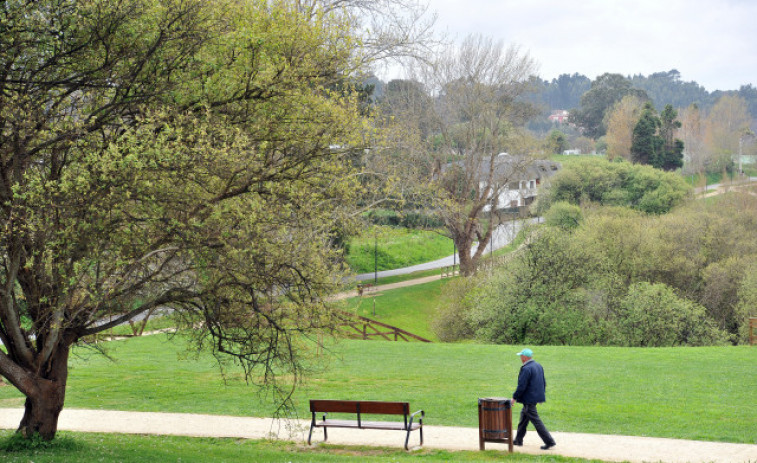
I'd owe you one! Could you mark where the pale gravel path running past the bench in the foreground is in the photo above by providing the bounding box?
[0,408,757,463]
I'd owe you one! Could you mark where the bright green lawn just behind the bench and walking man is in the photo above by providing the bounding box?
[0,335,757,444]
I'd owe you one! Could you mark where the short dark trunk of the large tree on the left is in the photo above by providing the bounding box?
[17,347,69,440]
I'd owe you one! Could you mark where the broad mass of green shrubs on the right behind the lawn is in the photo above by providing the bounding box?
[460,194,757,346]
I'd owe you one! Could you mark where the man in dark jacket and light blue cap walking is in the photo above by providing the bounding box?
[513,349,557,450]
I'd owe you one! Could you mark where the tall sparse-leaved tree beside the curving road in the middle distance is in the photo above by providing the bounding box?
[410,36,535,275]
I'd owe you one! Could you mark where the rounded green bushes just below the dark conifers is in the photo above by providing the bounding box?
[539,157,691,214]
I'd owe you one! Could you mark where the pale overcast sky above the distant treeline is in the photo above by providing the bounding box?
[416,0,757,92]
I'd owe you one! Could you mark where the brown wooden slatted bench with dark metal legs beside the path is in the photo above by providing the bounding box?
[308,400,426,450]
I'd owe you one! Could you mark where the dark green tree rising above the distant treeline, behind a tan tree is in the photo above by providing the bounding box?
[570,73,649,139]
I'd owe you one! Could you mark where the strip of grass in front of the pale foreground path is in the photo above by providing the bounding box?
[0,431,608,463]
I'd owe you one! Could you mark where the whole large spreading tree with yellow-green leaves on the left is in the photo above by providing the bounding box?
[0,0,384,439]
